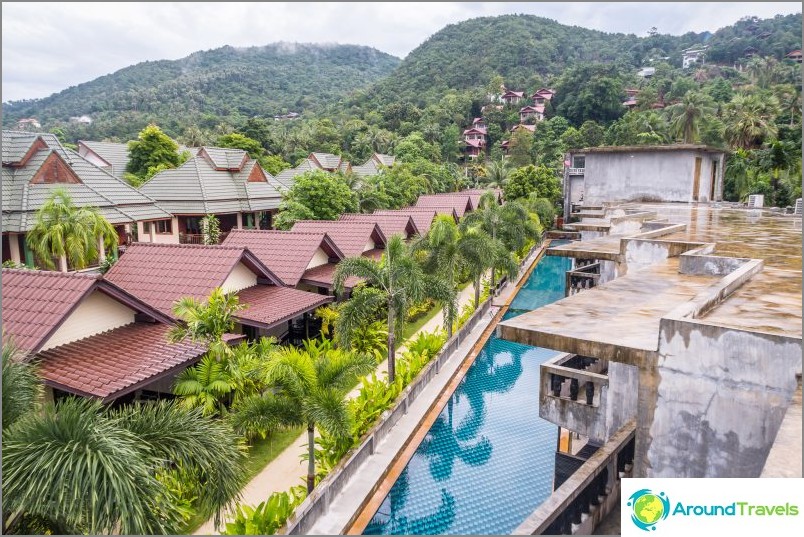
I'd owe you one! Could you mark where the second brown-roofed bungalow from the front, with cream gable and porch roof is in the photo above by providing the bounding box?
[106,243,332,343]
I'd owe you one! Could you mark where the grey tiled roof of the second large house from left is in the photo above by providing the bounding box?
[140,147,281,214]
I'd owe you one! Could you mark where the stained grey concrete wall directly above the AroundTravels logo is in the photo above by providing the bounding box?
[636,319,801,477]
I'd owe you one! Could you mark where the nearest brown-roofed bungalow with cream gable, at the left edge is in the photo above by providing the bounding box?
[2,269,239,402]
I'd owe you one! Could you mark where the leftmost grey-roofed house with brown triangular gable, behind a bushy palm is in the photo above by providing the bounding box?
[2,130,171,269]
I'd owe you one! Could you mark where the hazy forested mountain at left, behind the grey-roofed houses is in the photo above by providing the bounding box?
[3,43,399,140]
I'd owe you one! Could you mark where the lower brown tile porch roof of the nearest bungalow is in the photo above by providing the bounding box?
[38,323,242,401]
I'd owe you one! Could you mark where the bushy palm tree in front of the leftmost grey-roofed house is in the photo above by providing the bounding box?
[26,188,117,272]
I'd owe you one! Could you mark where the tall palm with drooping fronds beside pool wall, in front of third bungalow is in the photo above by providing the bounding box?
[334,235,455,383]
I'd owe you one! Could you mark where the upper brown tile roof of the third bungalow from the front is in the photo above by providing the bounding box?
[223,229,344,287]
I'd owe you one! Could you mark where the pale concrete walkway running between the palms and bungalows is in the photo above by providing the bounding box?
[194,284,484,535]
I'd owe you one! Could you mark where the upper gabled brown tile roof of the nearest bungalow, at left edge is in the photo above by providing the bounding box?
[2,269,170,353]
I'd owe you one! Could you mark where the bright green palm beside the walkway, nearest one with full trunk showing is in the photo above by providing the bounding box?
[240,343,376,493]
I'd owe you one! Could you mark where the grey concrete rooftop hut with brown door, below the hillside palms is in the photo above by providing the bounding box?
[570,151,722,204]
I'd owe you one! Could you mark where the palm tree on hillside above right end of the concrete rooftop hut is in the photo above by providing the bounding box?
[724,95,779,149]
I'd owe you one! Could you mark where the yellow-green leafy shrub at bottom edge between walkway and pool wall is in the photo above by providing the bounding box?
[223,487,307,535]
